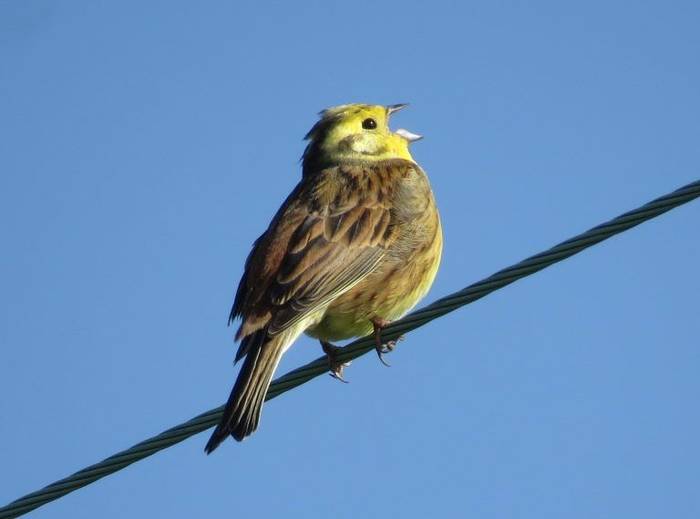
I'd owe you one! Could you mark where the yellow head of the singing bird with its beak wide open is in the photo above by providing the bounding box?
[302,104,421,170]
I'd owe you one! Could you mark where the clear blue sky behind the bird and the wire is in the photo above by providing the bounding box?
[0,0,700,519]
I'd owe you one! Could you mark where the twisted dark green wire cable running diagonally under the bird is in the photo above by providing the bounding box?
[0,180,700,519]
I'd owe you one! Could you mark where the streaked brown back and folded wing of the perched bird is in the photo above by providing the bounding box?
[230,161,412,358]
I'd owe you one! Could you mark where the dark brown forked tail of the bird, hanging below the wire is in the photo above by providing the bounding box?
[204,328,289,454]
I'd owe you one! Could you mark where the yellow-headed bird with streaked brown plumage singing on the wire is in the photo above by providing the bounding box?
[205,104,442,454]
